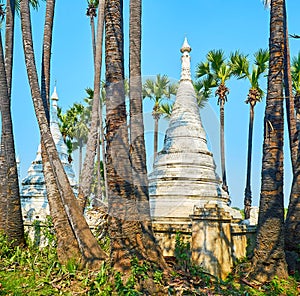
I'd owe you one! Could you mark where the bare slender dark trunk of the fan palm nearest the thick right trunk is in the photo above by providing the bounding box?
[244,102,254,219]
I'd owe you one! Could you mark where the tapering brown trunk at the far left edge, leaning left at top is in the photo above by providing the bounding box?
[0,28,25,245]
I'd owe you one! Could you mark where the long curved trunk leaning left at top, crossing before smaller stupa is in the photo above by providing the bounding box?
[20,0,106,268]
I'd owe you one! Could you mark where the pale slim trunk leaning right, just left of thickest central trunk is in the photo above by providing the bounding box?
[78,0,105,212]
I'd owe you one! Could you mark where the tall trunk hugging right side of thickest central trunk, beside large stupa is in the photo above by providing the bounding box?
[129,0,165,266]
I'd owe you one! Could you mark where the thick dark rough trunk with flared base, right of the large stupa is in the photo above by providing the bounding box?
[250,0,288,282]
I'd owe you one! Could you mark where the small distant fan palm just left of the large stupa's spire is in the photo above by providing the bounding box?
[143,74,177,159]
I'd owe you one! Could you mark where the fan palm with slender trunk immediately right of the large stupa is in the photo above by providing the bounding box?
[196,50,231,193]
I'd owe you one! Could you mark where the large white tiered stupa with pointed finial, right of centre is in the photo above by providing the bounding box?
[149,38,230,223]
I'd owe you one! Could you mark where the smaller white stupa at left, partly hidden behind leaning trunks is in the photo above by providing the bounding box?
[20,87,77,221]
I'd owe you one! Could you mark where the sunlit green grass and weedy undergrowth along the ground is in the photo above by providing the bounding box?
[0,229,299,296]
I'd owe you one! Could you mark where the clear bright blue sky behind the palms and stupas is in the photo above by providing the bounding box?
[7,0,300,207]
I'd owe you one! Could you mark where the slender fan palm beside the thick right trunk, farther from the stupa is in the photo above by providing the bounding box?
[230,49,269,219]
